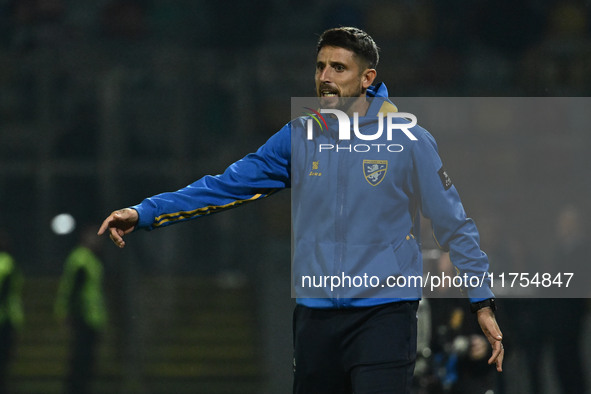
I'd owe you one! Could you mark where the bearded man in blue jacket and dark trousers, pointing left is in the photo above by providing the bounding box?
[98,27,504,394]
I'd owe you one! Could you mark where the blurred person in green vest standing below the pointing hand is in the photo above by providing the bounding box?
[55,227,107,394]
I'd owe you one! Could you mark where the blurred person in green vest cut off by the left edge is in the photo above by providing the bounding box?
[0,231,24,394]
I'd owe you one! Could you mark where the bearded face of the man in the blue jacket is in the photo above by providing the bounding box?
[315,46,375,108]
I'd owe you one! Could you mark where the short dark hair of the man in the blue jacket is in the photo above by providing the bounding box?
[316,27,380,68]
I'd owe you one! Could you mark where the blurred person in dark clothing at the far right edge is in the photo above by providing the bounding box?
[522,205,590,394]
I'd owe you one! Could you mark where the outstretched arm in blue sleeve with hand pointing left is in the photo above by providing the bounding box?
[98,124,291,248]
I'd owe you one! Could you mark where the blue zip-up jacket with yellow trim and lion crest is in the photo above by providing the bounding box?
[132,84,493,308]
